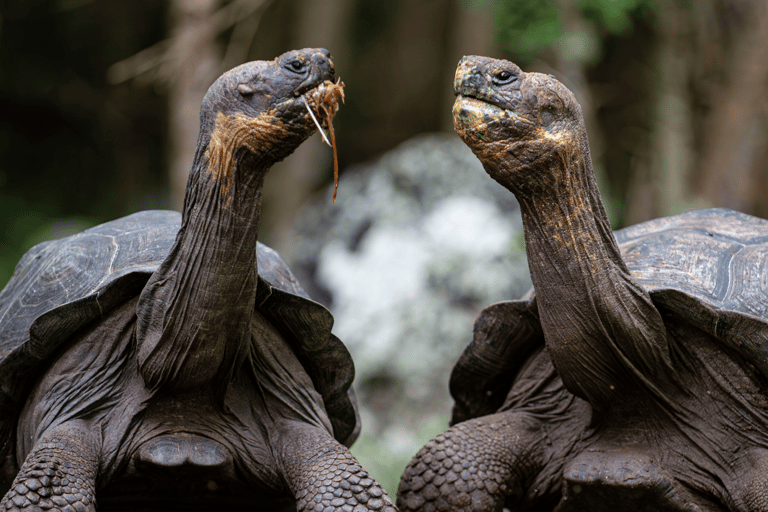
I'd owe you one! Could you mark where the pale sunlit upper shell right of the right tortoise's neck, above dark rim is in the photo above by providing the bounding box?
[616,208,768,320]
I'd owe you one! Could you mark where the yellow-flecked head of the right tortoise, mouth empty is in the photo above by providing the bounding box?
[453,56,589,193]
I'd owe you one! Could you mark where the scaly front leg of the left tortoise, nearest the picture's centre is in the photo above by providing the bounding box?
[280,423,397,512]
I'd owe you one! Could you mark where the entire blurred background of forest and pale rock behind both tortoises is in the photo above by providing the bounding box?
[0,0,768,493]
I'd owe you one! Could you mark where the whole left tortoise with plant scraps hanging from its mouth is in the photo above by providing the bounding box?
[0,49,394,511]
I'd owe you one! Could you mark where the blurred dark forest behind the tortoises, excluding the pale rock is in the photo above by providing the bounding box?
[0,0,768,500]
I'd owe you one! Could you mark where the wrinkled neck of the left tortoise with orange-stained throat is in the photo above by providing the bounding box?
[137,108,307,395]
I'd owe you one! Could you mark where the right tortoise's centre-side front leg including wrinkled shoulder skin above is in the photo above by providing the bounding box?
[397,349,590,512]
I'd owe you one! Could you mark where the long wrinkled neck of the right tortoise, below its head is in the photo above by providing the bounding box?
[498,135,671,409]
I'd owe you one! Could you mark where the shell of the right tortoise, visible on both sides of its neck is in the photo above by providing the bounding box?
[450,208,768,424]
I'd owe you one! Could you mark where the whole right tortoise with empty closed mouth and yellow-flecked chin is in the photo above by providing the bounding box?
[398,57,768,512]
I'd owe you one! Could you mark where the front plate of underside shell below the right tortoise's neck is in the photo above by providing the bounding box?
[558,447,701,512]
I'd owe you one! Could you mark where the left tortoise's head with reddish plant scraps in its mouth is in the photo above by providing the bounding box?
[201,48,342,165]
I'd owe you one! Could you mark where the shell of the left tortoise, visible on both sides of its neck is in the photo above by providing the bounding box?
[0,210,359,449]
